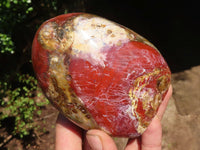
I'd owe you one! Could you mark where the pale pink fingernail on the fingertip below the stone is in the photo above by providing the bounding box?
[86,134,103,150]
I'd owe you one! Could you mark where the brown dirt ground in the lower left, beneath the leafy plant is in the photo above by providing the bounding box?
[0,104,58,150]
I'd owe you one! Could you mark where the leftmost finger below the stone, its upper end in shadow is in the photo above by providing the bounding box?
[55,115,82,150]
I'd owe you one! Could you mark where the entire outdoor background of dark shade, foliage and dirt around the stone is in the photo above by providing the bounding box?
[0,0,200,150]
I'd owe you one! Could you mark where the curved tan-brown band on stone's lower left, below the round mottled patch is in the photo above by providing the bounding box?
[46,54,98,129]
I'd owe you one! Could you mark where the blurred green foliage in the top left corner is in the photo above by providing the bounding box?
[0,0,33,54]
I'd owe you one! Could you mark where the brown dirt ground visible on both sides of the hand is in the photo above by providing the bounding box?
[0,66,200,150]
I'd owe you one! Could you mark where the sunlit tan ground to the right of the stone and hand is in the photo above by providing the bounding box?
[162,66,200,150]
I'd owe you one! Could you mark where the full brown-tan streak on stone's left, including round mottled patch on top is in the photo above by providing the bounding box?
[38,19,98,129]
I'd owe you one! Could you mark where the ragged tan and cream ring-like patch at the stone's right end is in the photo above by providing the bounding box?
[129,69,169,134]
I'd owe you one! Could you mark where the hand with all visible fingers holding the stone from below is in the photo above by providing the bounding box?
[55,86,172,150]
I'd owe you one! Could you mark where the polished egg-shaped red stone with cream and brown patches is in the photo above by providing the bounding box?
[32,13,171,137]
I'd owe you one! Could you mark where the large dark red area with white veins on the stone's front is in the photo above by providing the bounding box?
[69,41,169,136]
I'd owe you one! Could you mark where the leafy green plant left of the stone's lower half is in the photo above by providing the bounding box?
[0,74,48,138]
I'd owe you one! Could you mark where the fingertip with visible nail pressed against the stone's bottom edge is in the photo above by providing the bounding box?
[86,129,117,150]
